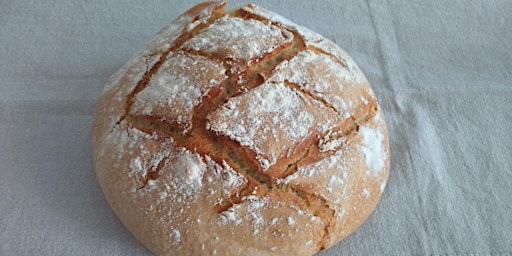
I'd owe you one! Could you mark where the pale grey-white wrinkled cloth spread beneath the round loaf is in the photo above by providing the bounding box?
[0,0,512,255]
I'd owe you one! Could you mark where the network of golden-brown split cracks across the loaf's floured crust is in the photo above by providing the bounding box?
[121,3,376,250]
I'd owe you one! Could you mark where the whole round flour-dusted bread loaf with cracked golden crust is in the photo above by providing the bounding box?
[93,2,389,255]
